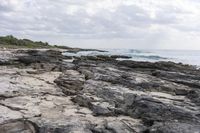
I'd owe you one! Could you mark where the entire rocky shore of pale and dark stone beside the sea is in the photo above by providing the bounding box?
[0,49,200,133]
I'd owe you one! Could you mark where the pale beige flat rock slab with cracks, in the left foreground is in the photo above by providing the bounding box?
[0,67,146,133]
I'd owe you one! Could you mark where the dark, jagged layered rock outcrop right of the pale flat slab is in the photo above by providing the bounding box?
[73,56,200,133]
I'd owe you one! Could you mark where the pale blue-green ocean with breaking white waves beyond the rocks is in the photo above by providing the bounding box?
[65,49,200,67]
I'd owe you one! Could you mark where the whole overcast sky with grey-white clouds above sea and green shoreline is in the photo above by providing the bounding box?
[0,0,200,50]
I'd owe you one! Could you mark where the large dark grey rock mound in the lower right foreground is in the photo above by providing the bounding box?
[127,97,200,123]
